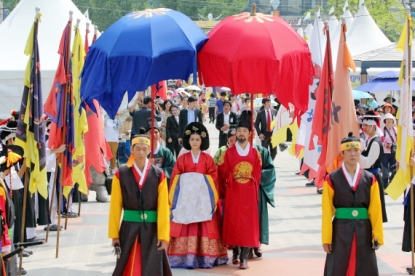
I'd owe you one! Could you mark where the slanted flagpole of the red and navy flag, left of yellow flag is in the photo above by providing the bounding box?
[55,11,73,258]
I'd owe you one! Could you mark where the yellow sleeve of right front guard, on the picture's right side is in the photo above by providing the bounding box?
[367,176,384,245]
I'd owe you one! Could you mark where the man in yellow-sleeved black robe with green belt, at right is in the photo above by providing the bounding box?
[322,133,383,276]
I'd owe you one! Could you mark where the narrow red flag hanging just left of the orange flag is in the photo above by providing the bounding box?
[310,25,333,187]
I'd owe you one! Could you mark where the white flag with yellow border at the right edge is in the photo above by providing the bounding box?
[385,16,413,200]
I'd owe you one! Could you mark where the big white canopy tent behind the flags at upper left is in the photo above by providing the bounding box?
[0,0,94,118]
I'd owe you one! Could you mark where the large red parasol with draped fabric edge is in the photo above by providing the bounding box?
[198,5,313,112]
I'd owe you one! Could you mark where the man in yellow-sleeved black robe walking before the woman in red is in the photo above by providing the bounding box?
[108,135,172,276]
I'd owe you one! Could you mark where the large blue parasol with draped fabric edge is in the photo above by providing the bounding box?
[81,8,208,117]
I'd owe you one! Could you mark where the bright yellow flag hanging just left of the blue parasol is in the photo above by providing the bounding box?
[64,27,88,196]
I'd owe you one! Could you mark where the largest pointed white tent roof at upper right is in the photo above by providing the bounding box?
[347,5,392,56]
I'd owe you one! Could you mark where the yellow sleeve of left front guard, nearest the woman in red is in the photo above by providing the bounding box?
[157,173,170,242]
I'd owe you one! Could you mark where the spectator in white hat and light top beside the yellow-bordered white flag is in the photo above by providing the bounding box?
[382,113,398,189]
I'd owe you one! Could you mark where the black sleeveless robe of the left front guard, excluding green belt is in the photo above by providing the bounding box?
[113,165,172,276]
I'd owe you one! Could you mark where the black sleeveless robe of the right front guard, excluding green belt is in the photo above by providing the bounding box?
[324,168,379,276]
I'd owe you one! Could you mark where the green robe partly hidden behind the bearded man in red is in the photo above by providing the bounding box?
[255,145,277,244]
